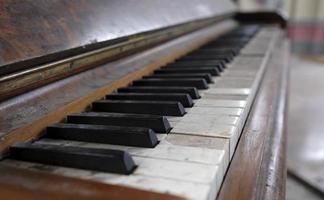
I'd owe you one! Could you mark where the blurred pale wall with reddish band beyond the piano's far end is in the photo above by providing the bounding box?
[238,0,324,55]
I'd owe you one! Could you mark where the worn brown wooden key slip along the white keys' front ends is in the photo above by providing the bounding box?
[218,32,289,200]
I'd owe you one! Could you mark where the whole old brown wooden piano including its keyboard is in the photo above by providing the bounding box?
[0,0,289,200]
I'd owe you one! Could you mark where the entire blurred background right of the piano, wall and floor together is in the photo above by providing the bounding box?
[238,0,324,200]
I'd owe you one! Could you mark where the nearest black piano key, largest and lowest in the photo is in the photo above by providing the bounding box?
[10,143,136,174]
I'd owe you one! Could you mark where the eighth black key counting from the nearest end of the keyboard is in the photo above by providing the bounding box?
[143,73,213,83]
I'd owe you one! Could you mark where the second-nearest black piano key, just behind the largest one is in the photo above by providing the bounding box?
[44,123,158,148]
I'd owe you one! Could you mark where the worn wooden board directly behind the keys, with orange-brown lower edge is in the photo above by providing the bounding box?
[0,22,236,156]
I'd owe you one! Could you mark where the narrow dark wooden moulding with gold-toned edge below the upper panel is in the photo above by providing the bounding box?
[0,18,225,101]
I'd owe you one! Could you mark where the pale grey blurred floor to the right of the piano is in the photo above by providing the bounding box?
[287,56,324,200]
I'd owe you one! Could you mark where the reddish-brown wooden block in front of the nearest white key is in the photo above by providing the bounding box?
[0,164,182,200]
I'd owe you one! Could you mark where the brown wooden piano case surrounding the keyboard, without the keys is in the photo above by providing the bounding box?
[0,0,289,199]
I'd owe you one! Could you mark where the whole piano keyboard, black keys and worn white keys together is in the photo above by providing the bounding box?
[2,25,279,199]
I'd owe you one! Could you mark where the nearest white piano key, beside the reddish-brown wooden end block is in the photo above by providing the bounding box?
[3,160,215,200]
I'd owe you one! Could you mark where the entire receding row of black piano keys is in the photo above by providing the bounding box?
[10,26,257,174]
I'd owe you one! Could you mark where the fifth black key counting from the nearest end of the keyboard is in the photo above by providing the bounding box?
[106,93,194,107]
